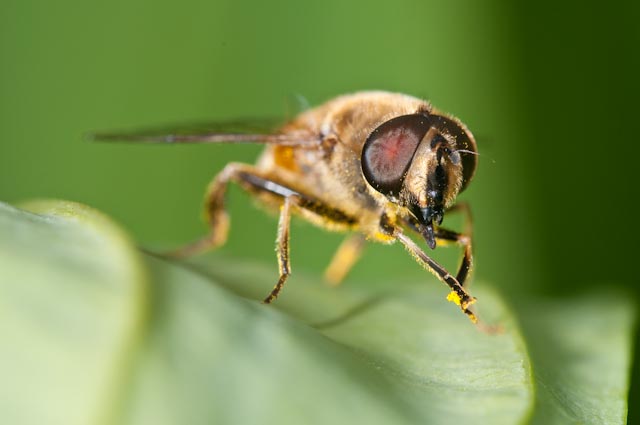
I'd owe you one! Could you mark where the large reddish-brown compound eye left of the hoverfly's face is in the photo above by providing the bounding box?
[362,114,430,196]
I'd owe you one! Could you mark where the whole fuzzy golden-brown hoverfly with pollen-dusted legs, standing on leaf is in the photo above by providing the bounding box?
[93,91,478,323]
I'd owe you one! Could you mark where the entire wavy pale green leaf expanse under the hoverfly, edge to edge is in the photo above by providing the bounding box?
[0,202,633,425]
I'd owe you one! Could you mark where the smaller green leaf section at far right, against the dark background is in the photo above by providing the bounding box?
[522,292,635,425]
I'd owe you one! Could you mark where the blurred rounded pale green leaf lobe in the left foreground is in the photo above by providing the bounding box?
[0,202,148,425]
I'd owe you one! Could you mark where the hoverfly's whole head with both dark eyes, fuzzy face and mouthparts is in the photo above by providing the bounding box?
[361,113,476,248]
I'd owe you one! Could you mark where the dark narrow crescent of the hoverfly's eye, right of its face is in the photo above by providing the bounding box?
[430,114,478,192]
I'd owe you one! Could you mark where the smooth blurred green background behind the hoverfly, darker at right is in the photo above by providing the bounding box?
[0,0,640,418]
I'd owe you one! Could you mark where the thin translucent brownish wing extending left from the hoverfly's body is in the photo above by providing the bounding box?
[87,118,319,146]
